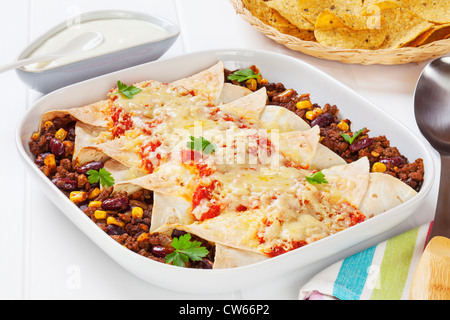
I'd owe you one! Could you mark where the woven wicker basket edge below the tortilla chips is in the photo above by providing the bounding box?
[230,0,450,65]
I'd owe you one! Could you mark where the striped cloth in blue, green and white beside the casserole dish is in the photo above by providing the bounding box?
[299,222,432,300]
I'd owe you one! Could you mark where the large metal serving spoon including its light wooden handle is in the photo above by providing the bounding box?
[409,57,450,300]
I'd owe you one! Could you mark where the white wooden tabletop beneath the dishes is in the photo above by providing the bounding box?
[0,0,440,299]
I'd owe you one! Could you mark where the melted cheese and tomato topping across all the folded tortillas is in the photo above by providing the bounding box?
[75,65,364,256]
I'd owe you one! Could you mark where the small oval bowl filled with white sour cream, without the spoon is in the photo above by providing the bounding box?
[16,11,180,93]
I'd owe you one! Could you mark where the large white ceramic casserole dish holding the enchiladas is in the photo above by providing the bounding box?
[16,49,435,294]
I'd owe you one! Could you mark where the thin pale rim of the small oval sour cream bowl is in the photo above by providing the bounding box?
[17,10,180,73]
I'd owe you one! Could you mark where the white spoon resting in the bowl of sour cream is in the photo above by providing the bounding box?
[0,31,103,73]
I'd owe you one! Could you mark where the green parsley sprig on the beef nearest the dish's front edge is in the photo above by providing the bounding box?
[166,233,209,267]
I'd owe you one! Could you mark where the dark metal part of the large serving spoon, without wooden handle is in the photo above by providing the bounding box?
[414,57,450,241]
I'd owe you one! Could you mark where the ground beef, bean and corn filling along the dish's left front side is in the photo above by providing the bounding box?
[29,116,214,269]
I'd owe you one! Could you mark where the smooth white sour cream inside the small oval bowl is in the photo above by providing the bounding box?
[25,19,169,70]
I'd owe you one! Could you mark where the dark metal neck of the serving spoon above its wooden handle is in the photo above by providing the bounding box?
[428,154,450,239]
